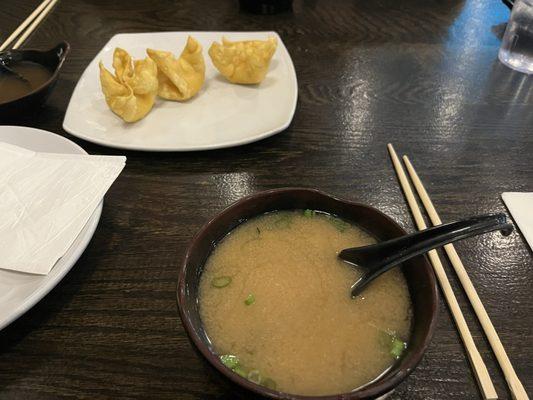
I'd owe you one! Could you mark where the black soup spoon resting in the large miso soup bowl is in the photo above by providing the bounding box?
[339,213,513,297]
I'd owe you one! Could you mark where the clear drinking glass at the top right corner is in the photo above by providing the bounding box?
[498,0,533,74]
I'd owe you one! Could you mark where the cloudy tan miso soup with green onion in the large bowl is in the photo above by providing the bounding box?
[199,210,412,395]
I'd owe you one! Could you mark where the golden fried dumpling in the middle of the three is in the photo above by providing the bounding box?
[146,36,205,101]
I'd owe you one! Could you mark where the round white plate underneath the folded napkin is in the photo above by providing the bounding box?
[0,126,102,329]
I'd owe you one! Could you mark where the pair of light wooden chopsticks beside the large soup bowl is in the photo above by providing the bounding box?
[387,143,529,400]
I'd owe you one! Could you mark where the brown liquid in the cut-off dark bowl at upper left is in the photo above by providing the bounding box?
[0,61,52,103]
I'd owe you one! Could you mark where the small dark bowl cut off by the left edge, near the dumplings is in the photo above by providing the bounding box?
[0,42,70,116]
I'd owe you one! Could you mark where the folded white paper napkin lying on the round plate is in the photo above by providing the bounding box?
[0,142,126,275]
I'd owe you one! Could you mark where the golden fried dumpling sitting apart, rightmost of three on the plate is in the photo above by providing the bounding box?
[209,38,278,84]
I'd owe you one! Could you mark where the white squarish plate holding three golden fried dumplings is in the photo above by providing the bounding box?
[63,32,298,151]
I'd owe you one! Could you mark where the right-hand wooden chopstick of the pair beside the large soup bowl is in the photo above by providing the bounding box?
[403,156,529,400]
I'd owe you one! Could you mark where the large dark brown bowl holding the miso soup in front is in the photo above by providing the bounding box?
[177,188,438,400]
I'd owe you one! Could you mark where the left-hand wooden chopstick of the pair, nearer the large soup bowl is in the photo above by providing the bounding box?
[387,143,498,400]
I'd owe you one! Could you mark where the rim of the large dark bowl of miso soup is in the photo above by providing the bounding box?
[176,187,439,400]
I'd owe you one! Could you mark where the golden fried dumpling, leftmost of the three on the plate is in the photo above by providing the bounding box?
[100,48,158,122]
